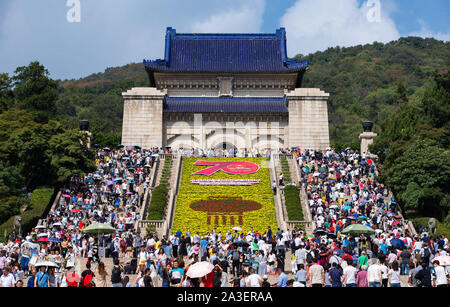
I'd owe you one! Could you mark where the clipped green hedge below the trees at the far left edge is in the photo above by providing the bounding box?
[0,187,57,240]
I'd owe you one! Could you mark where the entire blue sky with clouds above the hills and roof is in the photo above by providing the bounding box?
[0,0,450,79]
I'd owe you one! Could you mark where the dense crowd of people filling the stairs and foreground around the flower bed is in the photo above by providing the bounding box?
[0,147,450,287]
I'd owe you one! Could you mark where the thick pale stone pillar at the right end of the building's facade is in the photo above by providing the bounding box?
[286,88,330,150]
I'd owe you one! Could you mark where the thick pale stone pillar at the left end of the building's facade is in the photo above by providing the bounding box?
[122,87,165,149]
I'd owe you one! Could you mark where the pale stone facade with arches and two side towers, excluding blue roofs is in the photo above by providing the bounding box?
[122,80,330,150]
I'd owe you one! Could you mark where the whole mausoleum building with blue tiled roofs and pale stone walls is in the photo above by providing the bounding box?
[122,28,330,150]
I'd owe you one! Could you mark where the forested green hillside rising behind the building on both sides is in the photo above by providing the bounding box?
[57,37,450,145]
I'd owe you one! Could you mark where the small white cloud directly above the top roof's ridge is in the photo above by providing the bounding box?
[191,0,265,33]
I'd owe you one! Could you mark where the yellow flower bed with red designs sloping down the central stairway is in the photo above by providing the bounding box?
[172,158,277,234]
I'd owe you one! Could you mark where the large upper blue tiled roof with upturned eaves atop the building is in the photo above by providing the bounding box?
[144,28,308,73]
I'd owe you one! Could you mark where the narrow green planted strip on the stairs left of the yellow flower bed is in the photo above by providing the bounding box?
[147,156,172,221]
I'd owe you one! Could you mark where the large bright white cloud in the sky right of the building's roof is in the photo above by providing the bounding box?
[281,0,400,56]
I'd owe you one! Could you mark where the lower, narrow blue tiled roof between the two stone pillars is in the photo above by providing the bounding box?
[164,97,289,114]
